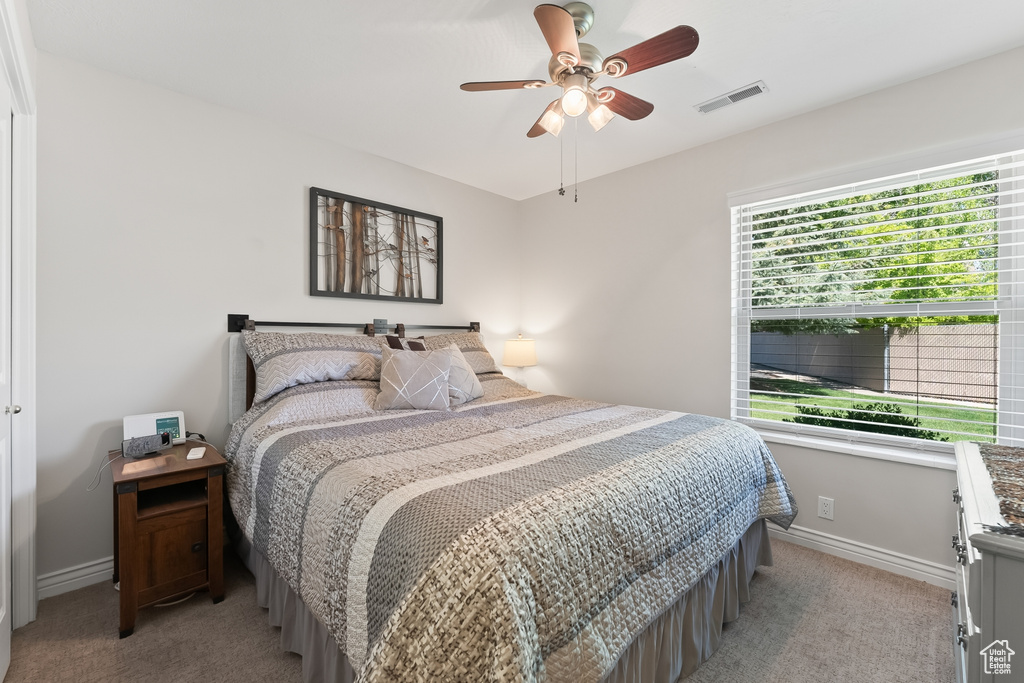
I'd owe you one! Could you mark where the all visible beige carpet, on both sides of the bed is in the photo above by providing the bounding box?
[5,541,952,683]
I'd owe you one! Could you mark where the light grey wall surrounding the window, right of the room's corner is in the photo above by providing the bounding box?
[522,49,1024,566]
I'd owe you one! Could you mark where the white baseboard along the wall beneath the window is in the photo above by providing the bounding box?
[768,524,956,591]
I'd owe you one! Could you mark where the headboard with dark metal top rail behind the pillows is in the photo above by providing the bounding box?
[227,313,480,424]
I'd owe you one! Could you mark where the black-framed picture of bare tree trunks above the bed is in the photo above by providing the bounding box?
[309,187,444,303]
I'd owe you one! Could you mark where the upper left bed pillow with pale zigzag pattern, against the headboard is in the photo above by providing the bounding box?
[242,330,384,403]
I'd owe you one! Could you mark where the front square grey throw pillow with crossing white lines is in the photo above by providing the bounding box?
[374,348,452,411]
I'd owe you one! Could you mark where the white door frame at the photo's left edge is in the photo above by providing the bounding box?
[0,0,38,629]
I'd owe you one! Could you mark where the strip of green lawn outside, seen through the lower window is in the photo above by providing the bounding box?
[751,379,995,442]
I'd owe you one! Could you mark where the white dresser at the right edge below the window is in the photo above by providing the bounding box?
[952,441,1024,683]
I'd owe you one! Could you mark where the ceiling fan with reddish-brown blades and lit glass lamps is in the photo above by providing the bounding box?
[461,2,698,137]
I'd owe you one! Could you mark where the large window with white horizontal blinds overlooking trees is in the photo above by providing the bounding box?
[732,153,1024,451]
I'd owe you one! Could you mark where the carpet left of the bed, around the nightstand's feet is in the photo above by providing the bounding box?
[4,553,302,683]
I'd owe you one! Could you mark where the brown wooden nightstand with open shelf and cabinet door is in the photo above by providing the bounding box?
[108,441,226,638]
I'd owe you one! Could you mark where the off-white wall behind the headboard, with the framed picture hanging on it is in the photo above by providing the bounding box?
[38,53,519,575]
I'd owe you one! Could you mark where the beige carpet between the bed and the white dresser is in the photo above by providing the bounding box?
[686,539,954,683]
